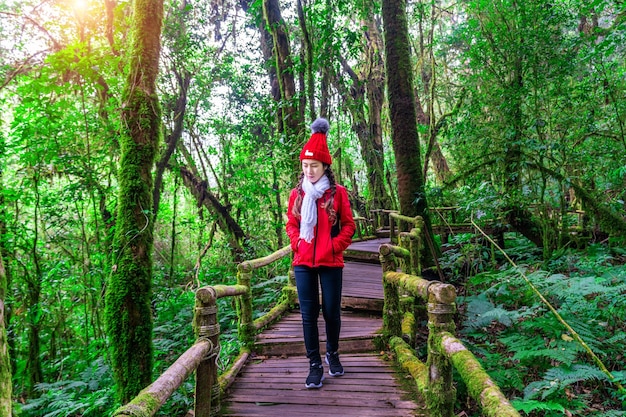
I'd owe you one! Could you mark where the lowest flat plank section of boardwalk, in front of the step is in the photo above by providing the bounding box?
[221,354,418,417]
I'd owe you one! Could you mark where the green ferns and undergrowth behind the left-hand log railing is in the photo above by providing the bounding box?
[16,264,288,417]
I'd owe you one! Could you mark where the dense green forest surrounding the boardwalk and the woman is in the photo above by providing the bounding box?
[0,0,626,417]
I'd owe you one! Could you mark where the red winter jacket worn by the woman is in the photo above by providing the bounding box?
[286,185,356,267]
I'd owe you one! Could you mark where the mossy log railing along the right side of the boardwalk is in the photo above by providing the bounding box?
[379,213,519,417]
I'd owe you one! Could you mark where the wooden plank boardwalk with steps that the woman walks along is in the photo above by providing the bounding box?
[221,239,422,417]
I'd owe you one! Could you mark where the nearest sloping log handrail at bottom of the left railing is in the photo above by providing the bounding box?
[112,340,213,417]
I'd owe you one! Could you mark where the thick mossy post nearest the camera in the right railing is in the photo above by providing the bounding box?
[425,281,456,417]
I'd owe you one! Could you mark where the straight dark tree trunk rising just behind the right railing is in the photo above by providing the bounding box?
[382,0,432,266]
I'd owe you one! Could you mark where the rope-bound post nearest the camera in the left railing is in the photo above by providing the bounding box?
[193,287,220,417]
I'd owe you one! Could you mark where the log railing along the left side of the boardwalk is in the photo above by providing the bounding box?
[113,246,297,417]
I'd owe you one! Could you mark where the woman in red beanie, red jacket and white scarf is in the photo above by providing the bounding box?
[286,118,355,388]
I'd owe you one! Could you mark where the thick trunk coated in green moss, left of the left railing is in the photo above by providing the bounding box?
[105,0,163,403]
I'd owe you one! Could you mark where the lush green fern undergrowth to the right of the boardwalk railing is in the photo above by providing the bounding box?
[459,245,626,417]
